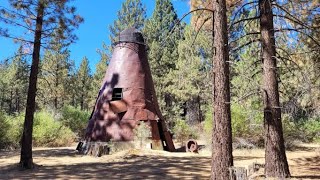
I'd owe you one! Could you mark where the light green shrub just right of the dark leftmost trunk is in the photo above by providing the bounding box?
[33,111,75,147]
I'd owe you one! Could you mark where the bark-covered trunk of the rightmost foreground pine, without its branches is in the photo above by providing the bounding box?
[259,0,290,178]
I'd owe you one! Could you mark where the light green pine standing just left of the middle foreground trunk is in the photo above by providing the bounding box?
[167,26,212,125]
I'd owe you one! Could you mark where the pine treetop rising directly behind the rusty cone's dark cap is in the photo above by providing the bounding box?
[109,0,146,44]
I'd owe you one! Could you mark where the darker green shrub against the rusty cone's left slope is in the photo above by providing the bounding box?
[60,106,90,136]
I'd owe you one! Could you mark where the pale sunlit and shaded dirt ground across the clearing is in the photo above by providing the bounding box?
[0,144,320,179]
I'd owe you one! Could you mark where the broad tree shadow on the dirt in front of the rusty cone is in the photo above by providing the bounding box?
[0,155,210,179]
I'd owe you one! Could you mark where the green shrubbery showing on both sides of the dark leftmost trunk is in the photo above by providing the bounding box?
[0,111,75,148]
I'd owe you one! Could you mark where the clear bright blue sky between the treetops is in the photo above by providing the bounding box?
[0,0,190,71]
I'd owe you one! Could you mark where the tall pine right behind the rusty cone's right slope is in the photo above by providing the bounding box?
[143,0,183,124]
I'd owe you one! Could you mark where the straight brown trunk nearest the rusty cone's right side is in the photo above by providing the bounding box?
[211,0,233,180]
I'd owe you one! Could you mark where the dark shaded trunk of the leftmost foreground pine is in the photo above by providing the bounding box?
[20,1,44,169]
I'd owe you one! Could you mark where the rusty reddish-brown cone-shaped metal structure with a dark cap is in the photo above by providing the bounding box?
[86,29,174,151]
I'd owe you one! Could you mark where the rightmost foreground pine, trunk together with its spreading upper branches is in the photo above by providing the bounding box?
[226,0,316,178]
